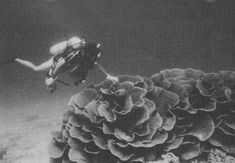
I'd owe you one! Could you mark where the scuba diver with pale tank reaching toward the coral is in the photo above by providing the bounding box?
[5,37,118,93]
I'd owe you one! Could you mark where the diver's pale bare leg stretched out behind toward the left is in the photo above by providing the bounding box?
[15,58,53,71]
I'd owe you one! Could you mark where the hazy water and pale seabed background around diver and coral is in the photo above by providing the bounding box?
[0,0,235,163]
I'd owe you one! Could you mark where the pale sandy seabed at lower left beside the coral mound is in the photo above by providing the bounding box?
[0,102,64,163]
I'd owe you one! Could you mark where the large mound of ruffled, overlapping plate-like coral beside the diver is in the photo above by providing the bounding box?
[50,69,235,163]
